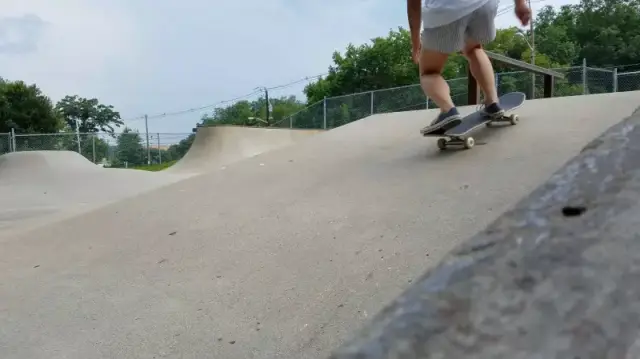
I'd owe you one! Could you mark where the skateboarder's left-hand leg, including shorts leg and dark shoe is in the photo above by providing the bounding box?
[420,21,466,131]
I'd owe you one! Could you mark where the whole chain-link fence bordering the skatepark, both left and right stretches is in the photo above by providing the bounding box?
[5,61,640,163]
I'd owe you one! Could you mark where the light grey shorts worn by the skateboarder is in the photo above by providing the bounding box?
[421,0,498,54]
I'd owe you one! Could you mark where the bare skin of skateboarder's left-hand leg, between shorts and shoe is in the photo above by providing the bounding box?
[420,49,454,112]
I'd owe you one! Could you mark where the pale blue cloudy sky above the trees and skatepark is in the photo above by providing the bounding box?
[0,0,578,139]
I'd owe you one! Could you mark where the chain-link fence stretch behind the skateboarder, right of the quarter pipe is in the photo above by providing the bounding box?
[278,66,640,129]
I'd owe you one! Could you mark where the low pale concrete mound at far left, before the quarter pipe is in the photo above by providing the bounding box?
[0,151,188,235]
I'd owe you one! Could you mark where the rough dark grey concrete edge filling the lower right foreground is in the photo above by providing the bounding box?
[330,107,640,359]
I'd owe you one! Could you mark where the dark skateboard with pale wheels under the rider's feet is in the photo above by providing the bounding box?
[423,92,526,150]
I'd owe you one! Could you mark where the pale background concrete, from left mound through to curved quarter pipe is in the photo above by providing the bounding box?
[0,126,322,236]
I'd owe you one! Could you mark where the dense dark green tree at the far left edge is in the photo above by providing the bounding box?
[0,78,62,133]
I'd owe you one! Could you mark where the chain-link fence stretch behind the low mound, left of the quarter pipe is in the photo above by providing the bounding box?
[8,132,195,168]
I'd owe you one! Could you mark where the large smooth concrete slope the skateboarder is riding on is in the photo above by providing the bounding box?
[0,92,640,359]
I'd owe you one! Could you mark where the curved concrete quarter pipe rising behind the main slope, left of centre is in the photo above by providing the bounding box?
[166,126,323,173]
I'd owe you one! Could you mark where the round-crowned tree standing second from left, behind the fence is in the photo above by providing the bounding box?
[56,95,124,135]
